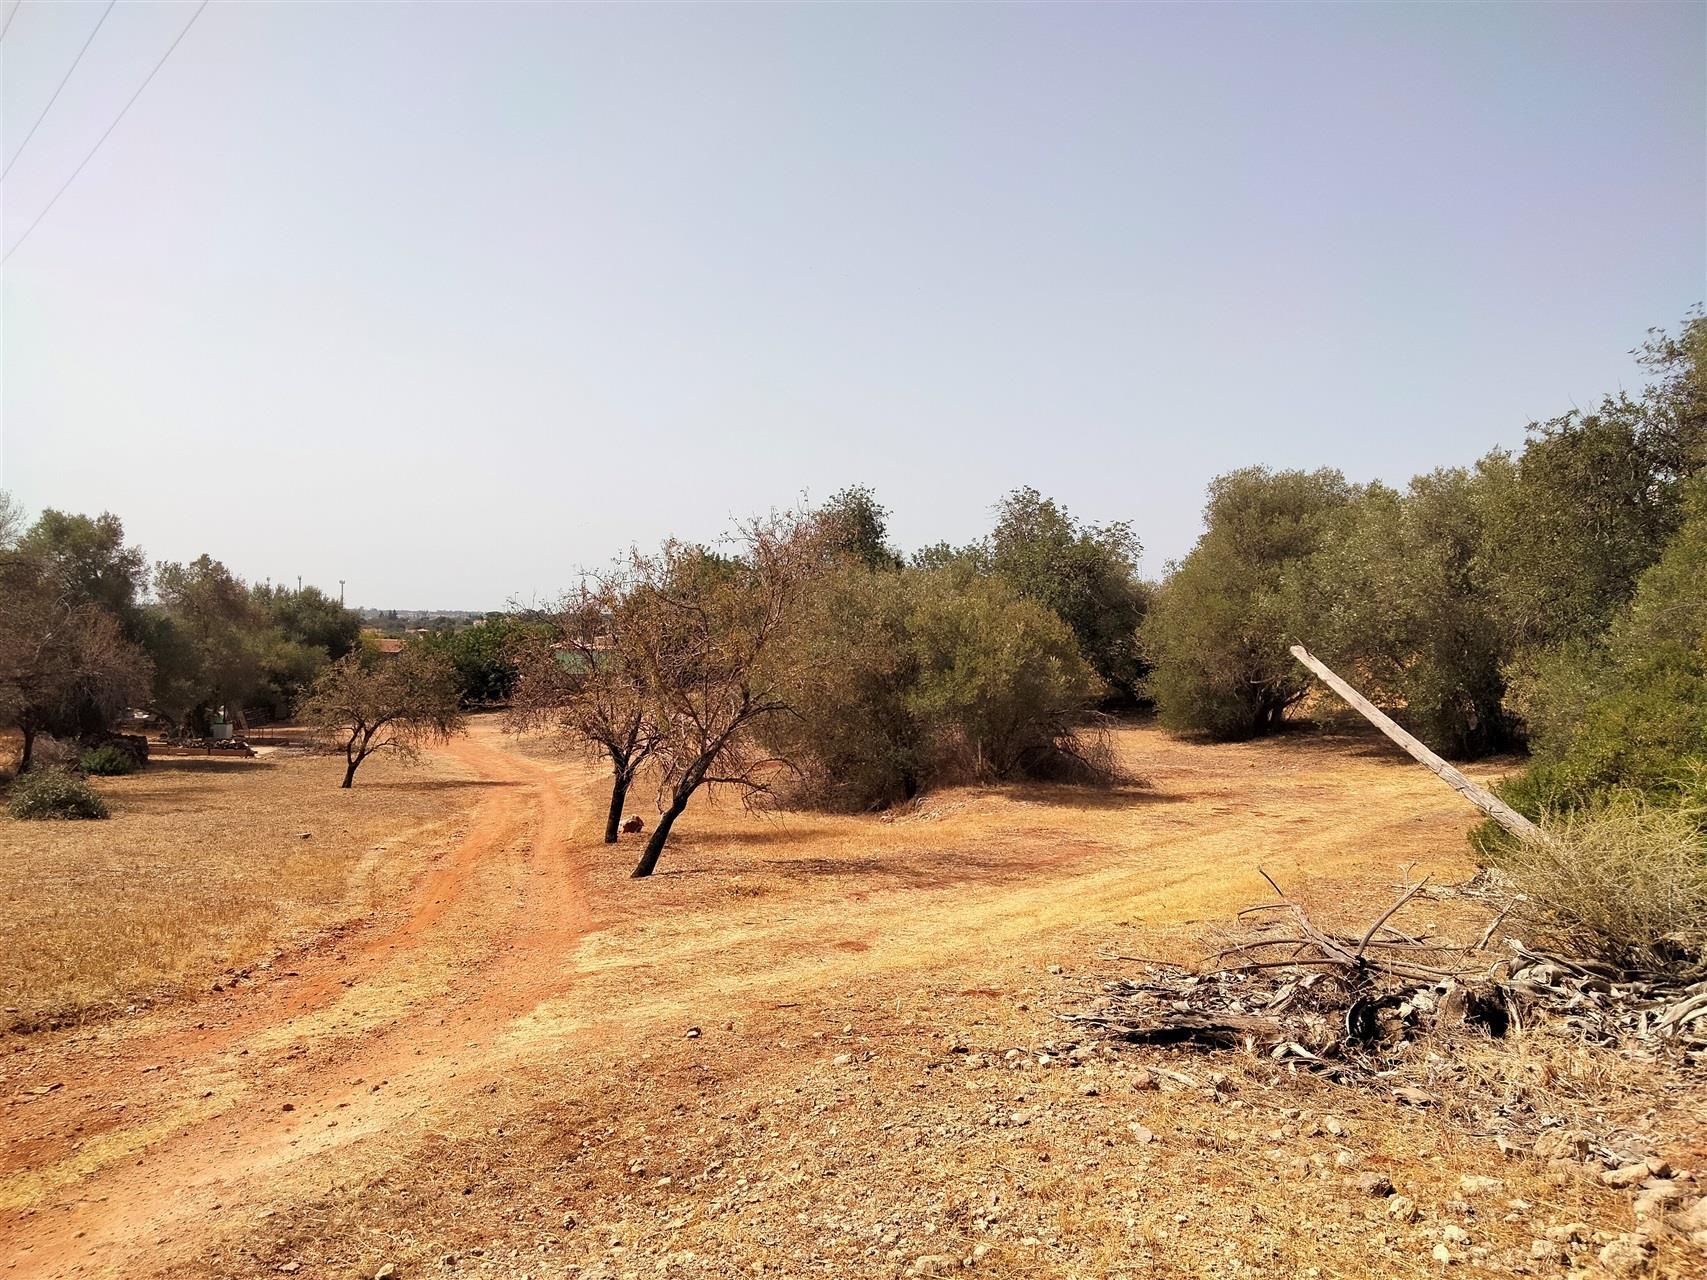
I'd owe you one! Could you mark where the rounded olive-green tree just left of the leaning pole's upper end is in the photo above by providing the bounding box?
[1140,468,1355,737]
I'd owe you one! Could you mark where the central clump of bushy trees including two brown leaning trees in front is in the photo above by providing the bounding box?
[512,488,1144,876]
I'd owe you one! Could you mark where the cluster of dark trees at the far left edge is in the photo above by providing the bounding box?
[0,495,362,771]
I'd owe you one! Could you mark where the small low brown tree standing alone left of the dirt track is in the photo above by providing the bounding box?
[297,649,463,787]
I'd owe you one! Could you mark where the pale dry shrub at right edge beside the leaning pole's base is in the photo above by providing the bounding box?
[1502,795,1707,969]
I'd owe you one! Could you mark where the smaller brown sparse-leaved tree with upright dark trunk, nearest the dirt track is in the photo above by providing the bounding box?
[509,587,659,845]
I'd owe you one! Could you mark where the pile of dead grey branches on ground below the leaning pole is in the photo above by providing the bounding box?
[1058,872,1707,1103]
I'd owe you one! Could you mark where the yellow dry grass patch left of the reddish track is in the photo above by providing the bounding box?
[0,754,459,1031]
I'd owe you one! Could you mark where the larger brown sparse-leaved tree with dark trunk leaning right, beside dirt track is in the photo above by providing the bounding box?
[621,512,823,877]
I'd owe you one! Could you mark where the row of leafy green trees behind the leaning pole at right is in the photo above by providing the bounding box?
[1140,312,1707,822]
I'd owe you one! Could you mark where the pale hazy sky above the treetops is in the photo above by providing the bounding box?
[0,0,1707,609]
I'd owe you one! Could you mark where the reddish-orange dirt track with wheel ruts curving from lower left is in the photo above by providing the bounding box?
[0,727,591,1277]
